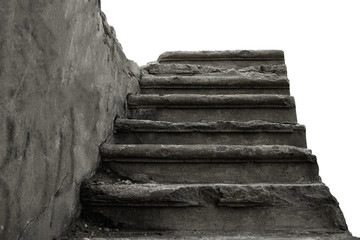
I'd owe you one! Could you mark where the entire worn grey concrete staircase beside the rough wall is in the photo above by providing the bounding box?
[77,51,352,239]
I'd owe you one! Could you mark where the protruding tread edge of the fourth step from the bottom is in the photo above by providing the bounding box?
[128,94,295,109]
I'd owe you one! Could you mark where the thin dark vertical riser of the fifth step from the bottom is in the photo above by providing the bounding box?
[141,87,290,95]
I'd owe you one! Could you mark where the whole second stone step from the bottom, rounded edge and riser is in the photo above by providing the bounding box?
[100,143,320,183]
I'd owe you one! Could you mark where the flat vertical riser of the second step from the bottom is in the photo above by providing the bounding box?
[103,159,319,184]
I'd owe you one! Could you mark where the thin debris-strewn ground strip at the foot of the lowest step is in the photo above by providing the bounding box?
[56,217,360,240]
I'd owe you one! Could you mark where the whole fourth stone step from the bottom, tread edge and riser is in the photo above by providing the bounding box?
[127,94,297,123]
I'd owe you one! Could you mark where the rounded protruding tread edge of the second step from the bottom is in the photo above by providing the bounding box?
[100,143,316,162]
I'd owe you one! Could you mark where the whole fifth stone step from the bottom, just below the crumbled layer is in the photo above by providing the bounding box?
[140,73,290,95]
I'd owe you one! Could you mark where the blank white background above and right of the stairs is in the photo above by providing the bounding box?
[102,0,360,236]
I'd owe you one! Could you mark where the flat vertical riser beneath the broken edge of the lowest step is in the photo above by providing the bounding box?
[83,205,342,231]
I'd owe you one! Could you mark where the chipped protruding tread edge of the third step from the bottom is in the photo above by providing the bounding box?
[114,117,305,133]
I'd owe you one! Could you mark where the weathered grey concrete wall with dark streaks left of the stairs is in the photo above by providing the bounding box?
[0,0,139,240]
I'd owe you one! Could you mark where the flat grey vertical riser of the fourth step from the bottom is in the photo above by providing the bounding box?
[128,106,297,123]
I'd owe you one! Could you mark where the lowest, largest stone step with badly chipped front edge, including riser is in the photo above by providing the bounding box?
[81,180,347,233]
